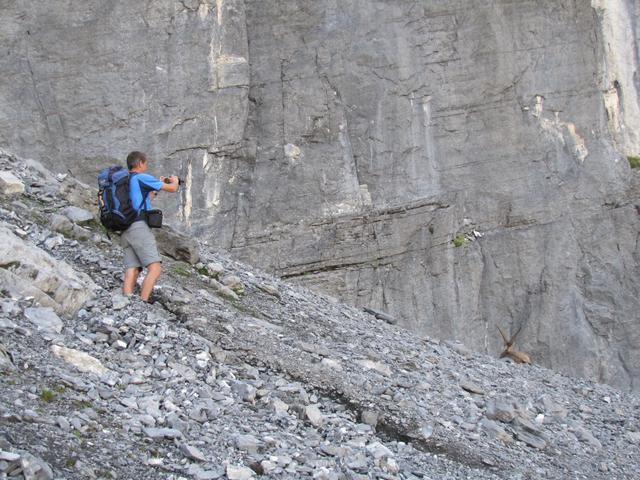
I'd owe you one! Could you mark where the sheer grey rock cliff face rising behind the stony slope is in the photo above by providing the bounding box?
[0,0,640,390]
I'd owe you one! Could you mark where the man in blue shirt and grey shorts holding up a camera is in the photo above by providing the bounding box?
[121,152,179,302]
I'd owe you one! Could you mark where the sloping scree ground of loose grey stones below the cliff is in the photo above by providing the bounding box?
[0,147,640,480]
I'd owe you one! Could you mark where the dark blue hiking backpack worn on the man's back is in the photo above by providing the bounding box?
[98,166,138,232]
